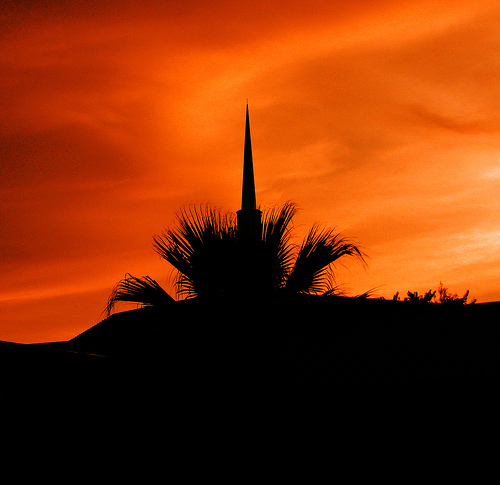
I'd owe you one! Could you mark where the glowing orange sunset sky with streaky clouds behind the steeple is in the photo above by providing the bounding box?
[0,0,500,342]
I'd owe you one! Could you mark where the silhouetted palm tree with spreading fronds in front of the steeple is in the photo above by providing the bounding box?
[106,202,365,315]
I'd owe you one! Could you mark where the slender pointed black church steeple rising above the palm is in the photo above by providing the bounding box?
[236,103,261,236]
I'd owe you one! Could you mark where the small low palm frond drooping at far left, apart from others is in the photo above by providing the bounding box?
[105,275,174,316]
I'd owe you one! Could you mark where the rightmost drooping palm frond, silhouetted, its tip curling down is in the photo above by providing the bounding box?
[286,225,365,294]
